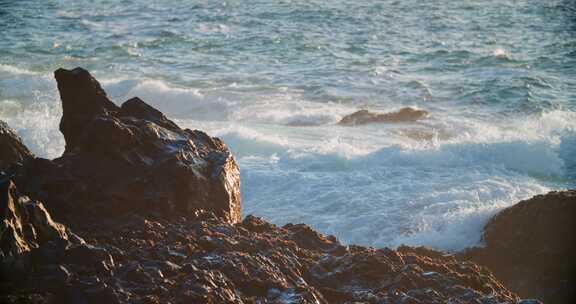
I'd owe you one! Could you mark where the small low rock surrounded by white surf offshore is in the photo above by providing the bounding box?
[338,107,428,126]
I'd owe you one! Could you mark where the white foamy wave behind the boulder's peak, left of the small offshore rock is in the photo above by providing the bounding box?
[103,79,358,126]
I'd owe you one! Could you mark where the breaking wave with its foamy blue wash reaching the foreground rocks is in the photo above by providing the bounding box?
[220,112,576,250]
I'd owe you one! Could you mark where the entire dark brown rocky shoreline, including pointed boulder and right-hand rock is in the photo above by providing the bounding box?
[0,68,576,304]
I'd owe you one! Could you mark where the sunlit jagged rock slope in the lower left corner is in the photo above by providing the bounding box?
[0,176,114,303]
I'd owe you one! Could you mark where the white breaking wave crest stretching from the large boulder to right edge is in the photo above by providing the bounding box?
[215,111,576,167]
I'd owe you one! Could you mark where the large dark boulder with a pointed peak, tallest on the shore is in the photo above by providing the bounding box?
[23,68,241,222]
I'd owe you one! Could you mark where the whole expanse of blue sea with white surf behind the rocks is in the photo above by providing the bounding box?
[0,0,576,250]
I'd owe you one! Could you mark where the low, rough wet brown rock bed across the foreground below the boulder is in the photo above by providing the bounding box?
[2,212,519,303]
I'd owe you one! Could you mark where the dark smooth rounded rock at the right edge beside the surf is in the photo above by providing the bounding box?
[463,190,576,303]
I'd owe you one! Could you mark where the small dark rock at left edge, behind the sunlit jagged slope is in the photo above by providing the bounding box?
[0,120,34,171]
